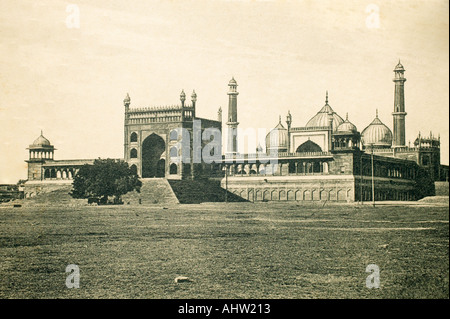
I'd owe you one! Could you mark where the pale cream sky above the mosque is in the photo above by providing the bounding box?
[0,0,449,183]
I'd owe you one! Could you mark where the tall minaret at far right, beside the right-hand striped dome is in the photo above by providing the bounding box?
[392,60,406,147]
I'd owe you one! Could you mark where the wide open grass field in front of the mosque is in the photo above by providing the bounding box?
[0,203,449,299]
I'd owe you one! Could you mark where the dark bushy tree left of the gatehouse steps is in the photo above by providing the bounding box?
[70,158,142,203]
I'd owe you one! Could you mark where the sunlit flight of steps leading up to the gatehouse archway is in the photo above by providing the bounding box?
[122,178,178,205]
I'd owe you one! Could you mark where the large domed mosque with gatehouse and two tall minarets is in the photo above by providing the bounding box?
[24,61,449,202]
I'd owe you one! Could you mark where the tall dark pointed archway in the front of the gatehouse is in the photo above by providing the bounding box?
[142,133,166,178]
